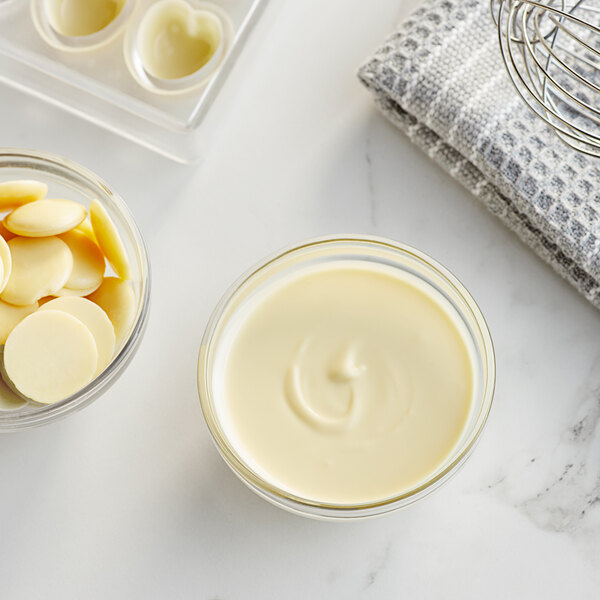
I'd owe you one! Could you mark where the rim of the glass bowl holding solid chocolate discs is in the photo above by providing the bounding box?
[0,147,151,433]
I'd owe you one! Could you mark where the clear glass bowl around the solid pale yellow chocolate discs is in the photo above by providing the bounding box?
[0,148,150,431]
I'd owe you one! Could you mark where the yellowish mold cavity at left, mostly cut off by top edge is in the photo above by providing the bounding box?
[44,0,127,37]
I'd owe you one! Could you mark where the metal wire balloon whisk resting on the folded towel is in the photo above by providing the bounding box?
[491,0,600,157]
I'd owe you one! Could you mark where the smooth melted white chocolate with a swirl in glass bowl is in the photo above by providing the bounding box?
[213,262,473,504]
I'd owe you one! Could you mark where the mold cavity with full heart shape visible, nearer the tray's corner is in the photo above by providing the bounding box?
[136,0,223,80]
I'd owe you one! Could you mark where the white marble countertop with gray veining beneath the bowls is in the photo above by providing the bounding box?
[0,0,600,600]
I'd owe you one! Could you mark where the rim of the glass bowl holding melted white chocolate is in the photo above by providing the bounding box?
[197,234,496,519]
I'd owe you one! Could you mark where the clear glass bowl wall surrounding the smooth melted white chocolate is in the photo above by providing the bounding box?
[198,235,495,520]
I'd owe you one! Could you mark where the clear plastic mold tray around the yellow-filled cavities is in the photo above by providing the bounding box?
[0,0,268,162]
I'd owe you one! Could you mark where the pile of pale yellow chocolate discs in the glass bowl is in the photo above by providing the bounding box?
[0,178,136,410]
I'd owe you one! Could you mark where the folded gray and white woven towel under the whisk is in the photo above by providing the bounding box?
[359,0,600,308]
